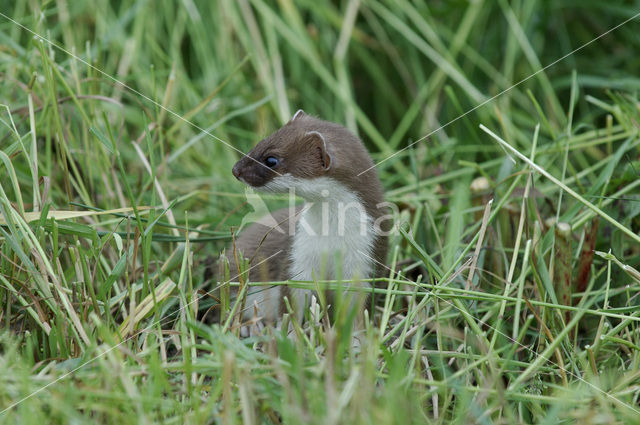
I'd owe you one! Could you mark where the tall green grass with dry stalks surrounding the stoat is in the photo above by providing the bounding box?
[0,0,640,424]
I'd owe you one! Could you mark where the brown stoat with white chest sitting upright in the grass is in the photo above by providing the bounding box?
[212,110,389,322]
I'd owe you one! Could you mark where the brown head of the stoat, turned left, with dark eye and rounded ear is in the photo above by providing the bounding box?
[233,110,332,192]
